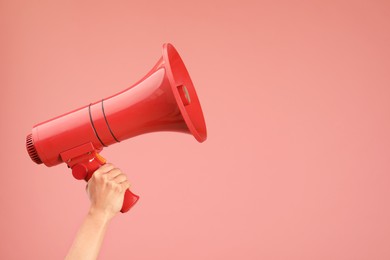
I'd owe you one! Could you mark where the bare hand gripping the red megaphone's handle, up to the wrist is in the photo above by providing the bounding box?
[87,163,130,220]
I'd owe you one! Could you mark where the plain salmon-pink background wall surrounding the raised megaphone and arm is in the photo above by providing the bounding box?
[0,0,390,260]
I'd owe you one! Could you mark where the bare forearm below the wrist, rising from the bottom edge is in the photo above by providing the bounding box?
[65,210,110,260]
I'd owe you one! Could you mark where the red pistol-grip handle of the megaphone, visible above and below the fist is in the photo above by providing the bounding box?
[72,152,139,213]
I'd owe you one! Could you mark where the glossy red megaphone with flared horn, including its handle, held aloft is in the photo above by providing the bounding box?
[26,43,207,212]
